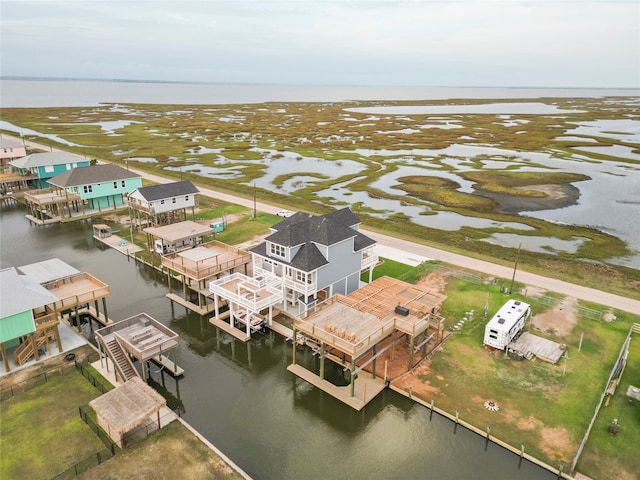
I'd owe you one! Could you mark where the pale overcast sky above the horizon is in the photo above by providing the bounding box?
[0,0,640,88]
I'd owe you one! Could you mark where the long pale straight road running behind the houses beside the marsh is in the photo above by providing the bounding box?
[8,134,640,315]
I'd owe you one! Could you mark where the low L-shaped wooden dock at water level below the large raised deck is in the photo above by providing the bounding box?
[287,364,385,411]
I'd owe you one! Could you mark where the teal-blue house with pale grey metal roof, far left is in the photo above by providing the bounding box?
[9,152,89,189]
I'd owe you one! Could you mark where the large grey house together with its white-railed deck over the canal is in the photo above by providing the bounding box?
[209,208,378,341]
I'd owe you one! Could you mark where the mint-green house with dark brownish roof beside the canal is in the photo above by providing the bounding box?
[49,163,142,210]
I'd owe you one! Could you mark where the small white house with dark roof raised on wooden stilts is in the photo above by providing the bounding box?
[129,181,200,228]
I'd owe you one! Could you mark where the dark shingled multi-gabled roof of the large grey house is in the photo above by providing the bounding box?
[251,208,376,272]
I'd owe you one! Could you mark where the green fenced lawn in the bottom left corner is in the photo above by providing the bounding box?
[0,369,105,479]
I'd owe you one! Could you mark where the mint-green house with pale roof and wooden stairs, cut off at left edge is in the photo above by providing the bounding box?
[0,268,62,372]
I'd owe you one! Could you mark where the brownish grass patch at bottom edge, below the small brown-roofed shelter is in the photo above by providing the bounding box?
[78,420,243,480]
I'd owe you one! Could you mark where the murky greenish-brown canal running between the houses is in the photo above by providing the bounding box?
[0,206,556,480]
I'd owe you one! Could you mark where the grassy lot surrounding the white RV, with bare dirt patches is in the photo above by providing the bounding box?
[397,268,640,478]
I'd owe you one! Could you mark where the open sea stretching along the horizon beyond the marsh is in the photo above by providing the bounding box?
[0,78,640,108]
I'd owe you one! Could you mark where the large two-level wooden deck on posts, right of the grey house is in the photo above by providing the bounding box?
[288,277,446,408]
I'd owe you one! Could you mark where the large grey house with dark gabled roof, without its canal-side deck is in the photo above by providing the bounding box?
[250,208,378,311]
